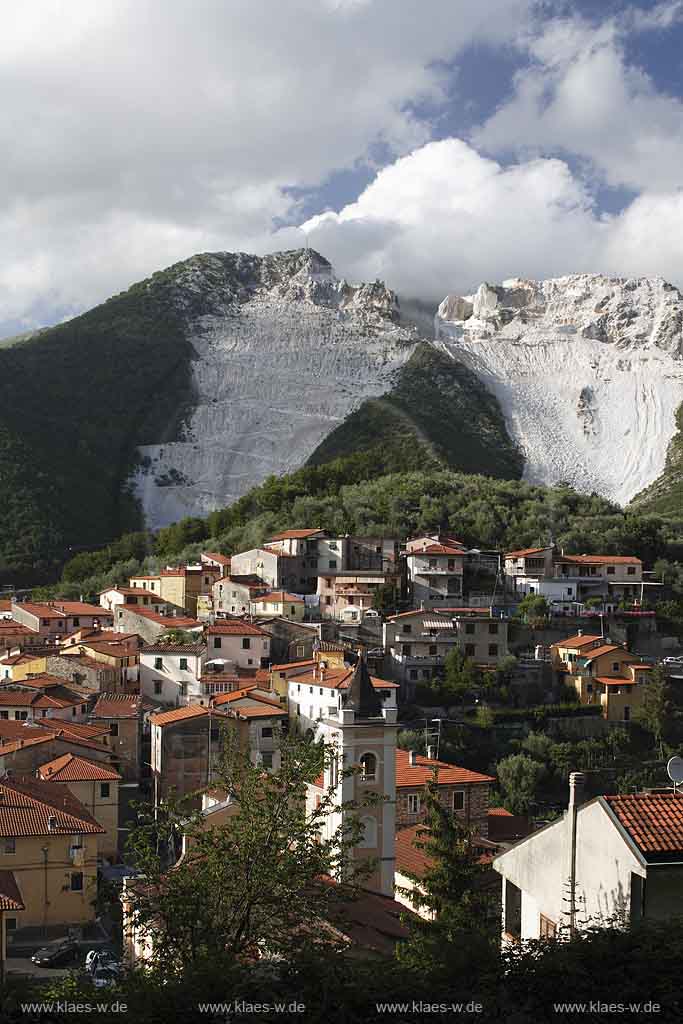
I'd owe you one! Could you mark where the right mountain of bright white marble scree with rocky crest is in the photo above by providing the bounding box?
[435,273,683,504]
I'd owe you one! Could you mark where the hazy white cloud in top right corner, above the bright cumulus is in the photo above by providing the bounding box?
[472,3,683,190]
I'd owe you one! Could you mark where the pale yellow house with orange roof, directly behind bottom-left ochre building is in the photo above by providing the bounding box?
[37,754,121,859]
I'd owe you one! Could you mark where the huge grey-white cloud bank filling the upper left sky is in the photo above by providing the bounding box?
[0,0,530,331]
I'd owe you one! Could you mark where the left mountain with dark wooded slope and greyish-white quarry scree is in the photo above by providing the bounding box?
[0,249,519,584]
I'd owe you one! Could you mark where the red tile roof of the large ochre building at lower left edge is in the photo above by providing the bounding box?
[0,777,104,836]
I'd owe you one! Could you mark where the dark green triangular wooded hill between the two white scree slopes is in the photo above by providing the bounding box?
[308,342,524,479]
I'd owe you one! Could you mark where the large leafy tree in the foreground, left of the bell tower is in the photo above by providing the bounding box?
[129,730,376,974]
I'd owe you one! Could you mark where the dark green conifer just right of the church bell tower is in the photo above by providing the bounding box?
[397,772,499,976]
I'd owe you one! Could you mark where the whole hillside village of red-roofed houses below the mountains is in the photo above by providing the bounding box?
[0,520,683,983]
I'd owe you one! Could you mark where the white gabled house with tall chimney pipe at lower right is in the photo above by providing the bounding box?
[494,772,683,942]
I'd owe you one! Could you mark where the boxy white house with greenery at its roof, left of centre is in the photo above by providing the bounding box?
[139,641,207,707]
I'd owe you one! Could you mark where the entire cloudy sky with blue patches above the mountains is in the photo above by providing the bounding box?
[0,0,683,338]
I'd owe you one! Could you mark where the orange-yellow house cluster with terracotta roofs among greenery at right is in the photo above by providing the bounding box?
[550,634,652,722]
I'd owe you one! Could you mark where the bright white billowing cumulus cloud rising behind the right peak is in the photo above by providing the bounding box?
[296,138,683,301]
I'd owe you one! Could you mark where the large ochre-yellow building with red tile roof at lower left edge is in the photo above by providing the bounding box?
[0,777,104,930]
